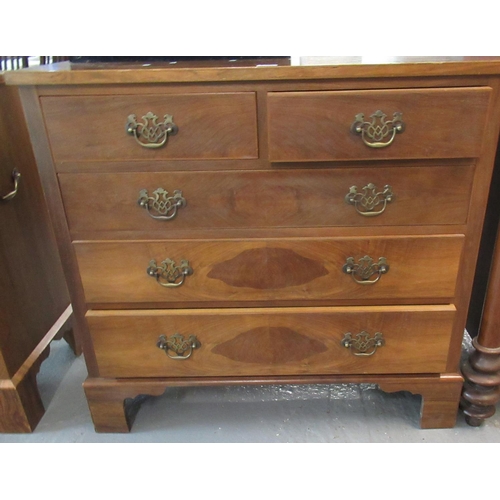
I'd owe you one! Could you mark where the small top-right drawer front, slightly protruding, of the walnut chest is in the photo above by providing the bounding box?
[268,87,491,162]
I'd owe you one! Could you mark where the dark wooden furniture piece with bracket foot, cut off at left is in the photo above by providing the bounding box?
[0,84,75,433]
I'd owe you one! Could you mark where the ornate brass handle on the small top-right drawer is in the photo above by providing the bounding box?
[351,110,405,148]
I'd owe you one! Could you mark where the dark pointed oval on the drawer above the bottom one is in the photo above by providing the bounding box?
[208,248,328,290]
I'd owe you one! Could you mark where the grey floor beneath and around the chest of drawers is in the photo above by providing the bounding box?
[0,336,500,443]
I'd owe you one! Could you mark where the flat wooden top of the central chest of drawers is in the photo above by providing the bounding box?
[4,56,500,85]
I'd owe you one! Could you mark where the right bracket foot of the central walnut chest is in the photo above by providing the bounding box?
[379,375,463,429]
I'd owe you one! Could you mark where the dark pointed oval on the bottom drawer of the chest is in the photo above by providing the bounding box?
[212,327,327,363]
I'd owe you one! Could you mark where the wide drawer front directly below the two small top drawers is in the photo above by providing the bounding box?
[59,166,474,234]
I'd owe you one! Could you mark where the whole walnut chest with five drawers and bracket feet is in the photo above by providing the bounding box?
[8,60,500,432]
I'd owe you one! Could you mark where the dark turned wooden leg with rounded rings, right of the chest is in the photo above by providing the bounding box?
[460,339,500,427]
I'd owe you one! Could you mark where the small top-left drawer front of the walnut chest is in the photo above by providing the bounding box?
[41,92,258,161]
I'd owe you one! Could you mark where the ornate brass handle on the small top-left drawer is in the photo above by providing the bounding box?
[126,111,179,149]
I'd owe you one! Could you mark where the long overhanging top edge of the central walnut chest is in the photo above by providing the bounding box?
[5,56,500,86]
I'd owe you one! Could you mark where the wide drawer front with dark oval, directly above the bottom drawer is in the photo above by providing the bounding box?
[74,235,463,307]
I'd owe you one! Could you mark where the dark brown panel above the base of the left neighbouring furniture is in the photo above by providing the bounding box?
[0,84,69,376]
